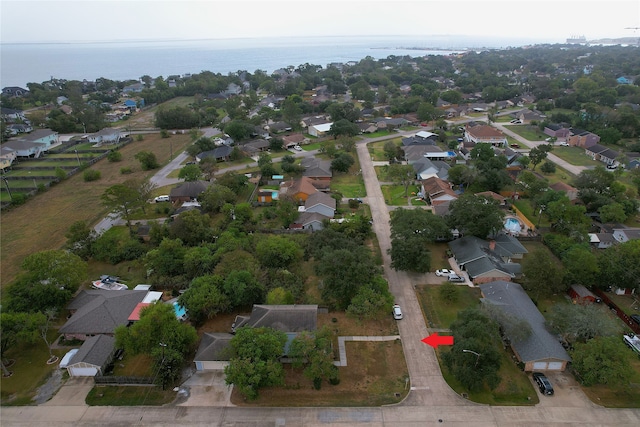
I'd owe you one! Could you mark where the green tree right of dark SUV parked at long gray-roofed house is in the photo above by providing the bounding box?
[570,337,633,387]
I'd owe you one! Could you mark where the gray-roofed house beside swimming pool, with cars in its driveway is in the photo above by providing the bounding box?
[448,234,527,284]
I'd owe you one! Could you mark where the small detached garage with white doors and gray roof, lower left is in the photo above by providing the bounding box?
[67,335,116,377]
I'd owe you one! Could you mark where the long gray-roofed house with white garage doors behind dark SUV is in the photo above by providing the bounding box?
[480,281,571,371]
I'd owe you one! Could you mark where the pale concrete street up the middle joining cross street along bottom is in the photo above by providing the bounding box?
[6,135,640,427]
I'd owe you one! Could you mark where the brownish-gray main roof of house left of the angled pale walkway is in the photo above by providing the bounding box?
[234,304,318,332]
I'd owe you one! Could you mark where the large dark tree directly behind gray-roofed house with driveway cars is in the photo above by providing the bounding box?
[446,193,504,239]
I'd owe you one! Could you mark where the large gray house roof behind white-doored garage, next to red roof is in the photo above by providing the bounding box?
[60,289,147,335]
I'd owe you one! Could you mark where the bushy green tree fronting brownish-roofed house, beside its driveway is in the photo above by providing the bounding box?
[224,327,287,400]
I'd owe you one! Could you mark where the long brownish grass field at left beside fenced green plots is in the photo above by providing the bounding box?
[0,134,190,287]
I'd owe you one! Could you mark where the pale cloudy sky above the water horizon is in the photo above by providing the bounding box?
[0,0,640,43]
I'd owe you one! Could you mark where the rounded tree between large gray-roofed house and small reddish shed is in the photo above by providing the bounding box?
[522,249,567,300]
